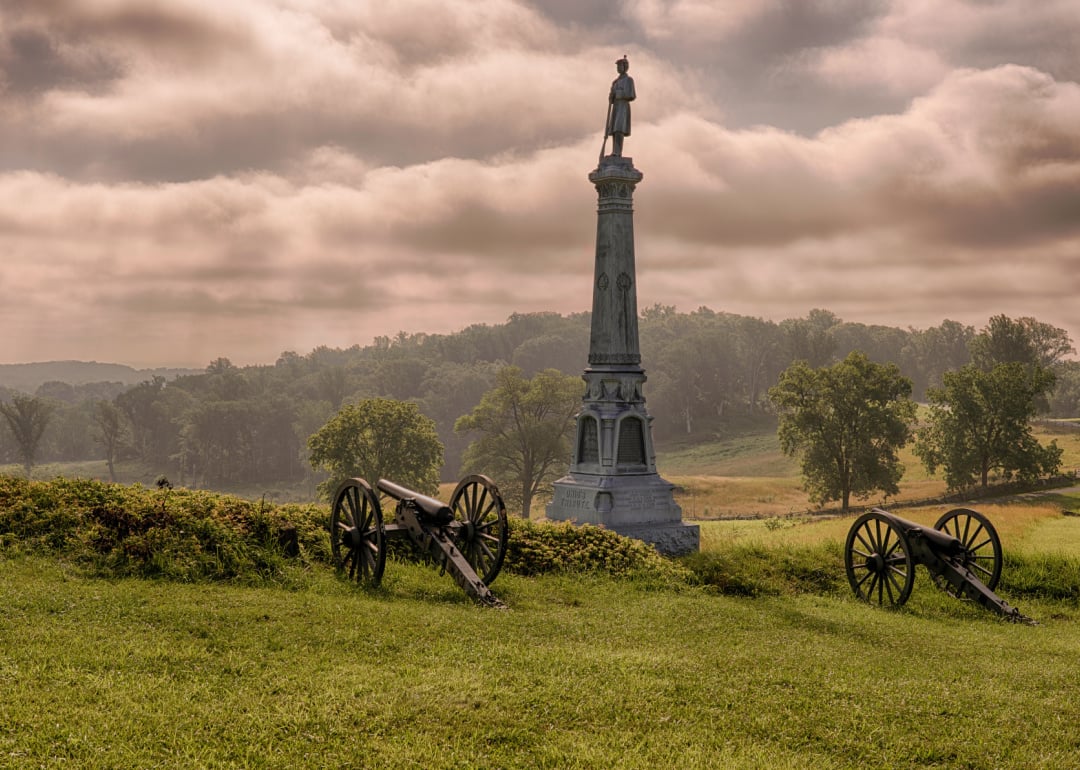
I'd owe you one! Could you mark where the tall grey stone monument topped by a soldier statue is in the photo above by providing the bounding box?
[546,56,699,555]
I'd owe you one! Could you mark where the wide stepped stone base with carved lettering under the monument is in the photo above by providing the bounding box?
[546,472,700,556]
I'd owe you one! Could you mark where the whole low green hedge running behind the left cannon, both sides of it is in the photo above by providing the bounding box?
[0,476,691,584]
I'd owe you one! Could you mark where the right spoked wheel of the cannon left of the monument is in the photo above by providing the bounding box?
[450,474,510,585]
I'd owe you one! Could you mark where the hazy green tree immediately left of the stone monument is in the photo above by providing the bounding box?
[454,366,582,518]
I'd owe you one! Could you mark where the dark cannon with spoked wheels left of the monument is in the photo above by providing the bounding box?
[329,474,510,608]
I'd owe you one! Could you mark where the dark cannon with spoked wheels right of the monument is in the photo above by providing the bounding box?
[843,508,1029,621]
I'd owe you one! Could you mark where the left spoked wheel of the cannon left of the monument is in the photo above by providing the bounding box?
[330,478,387,585]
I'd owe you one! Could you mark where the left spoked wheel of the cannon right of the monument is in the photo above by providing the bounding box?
[843,511,915,607]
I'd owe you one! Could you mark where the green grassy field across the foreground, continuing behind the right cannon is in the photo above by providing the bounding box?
[0,494,1080,769]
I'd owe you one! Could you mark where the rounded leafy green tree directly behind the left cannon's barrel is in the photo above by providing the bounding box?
[308,398,443,496]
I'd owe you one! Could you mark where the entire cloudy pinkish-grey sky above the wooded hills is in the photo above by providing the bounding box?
[0,0,1080,366]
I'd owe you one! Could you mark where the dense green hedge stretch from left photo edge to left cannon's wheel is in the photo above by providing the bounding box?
[0,476,329,581]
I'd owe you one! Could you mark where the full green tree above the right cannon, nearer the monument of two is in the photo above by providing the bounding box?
[769,351,916,511]
